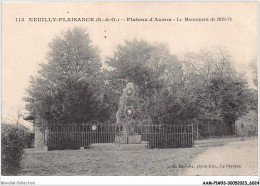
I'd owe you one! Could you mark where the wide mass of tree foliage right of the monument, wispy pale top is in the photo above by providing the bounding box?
[149,49,257,134]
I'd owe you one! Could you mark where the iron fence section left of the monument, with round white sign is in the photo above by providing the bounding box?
[47,124,116,149]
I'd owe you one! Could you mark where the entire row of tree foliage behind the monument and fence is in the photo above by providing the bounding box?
[25,28,257,137]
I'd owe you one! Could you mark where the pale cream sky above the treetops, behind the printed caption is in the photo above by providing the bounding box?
[1,2,257,129]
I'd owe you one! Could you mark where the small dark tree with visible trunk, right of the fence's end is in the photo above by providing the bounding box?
[207,77,250,134]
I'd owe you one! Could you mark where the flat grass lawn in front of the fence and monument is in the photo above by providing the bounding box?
[19,138,250,176]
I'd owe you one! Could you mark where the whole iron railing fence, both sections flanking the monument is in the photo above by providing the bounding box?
[46,124,194,149]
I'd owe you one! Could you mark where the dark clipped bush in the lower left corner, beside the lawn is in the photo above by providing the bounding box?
[1,124,29,175]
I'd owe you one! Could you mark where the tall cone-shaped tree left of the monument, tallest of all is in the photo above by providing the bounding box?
[25,27,108,127]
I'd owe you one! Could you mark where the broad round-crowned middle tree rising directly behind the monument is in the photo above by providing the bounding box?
[106,40,180,122]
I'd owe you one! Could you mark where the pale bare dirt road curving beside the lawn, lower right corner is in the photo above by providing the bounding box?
[183,138,258,176]
